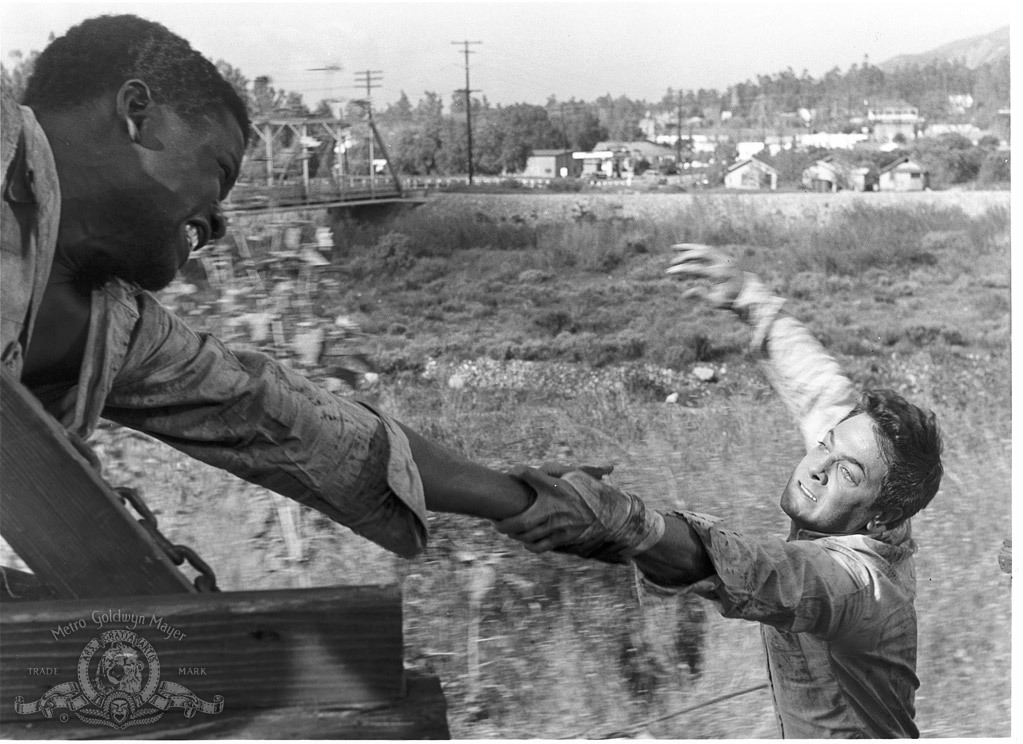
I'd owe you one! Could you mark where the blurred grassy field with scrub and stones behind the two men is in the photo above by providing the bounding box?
[85,192,1011,738]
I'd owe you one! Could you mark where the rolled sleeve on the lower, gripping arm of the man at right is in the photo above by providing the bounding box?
[642,512,871,639]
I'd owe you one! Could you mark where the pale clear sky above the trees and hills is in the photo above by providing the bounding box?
[0,0,1010,106]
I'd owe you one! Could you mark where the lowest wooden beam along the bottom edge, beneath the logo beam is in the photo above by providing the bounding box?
[3,675,451,741]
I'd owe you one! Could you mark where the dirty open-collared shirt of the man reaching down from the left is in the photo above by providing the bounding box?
[0,95,427,556]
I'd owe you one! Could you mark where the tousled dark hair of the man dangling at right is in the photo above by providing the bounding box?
[847,390,944,519]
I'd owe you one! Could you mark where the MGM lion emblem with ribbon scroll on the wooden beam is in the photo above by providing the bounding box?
[14,630,224,729]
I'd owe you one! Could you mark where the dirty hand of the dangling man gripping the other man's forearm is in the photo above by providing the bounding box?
[495,464,664,563]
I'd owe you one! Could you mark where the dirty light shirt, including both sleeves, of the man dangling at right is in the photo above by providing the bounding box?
[643,315,920,739]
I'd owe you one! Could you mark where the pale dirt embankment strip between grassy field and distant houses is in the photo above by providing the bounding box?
[422,191,1011,222]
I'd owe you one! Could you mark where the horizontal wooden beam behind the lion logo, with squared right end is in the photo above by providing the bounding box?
[0,586,403,724]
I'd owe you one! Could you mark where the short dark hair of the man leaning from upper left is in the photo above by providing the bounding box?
[21,15,250,144]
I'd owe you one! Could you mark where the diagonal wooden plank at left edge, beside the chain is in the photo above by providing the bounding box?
[0,367,194,599]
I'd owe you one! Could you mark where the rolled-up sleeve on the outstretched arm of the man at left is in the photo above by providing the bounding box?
[102,294,427,556]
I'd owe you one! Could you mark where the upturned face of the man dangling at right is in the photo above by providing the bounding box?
[782,413,888,534]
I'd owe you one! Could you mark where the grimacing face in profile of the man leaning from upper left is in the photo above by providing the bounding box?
[66,106,244,290]
